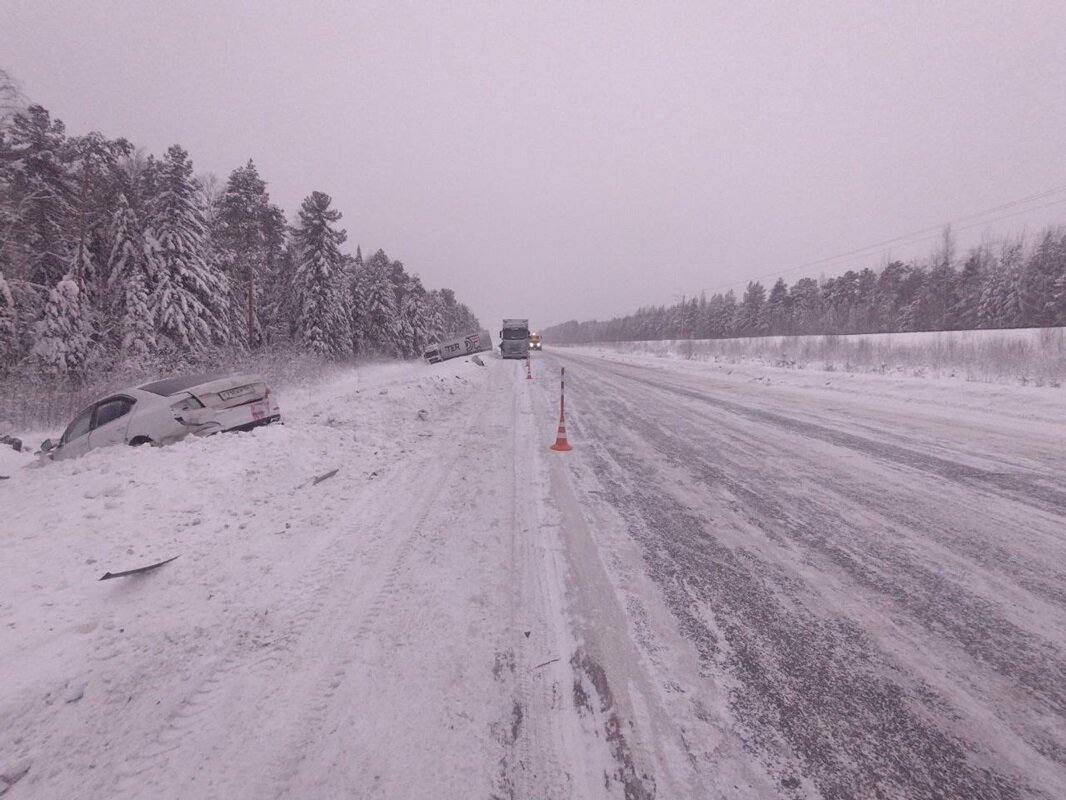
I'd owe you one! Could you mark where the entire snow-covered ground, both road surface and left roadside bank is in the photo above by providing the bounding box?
[0,348,1066,800]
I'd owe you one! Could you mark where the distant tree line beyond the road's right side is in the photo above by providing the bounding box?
[543,228,1066,345]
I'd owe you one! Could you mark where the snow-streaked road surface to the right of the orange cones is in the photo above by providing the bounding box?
[550,347,1066,798]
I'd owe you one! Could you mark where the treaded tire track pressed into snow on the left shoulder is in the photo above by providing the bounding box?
[102,375,494,798]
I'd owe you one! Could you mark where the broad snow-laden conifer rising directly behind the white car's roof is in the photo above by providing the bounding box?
[145,145,229,353]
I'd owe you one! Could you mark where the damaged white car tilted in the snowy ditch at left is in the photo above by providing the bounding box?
[41,374,281,459]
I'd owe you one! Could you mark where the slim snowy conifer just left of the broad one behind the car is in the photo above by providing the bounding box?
[108,194,157,362]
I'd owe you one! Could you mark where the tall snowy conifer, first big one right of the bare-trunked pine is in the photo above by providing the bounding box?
[293,192,352,357]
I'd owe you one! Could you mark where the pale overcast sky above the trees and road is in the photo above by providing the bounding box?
[0,0,1066,333]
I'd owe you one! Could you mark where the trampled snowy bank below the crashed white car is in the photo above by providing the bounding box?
[0,361,503,798]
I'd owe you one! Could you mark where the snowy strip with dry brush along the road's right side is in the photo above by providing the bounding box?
[587,327,1066,388]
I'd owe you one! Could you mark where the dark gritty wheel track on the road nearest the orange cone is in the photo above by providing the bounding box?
[554,356,1063,798]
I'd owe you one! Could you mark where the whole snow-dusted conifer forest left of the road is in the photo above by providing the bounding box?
[0,73,480,386]
